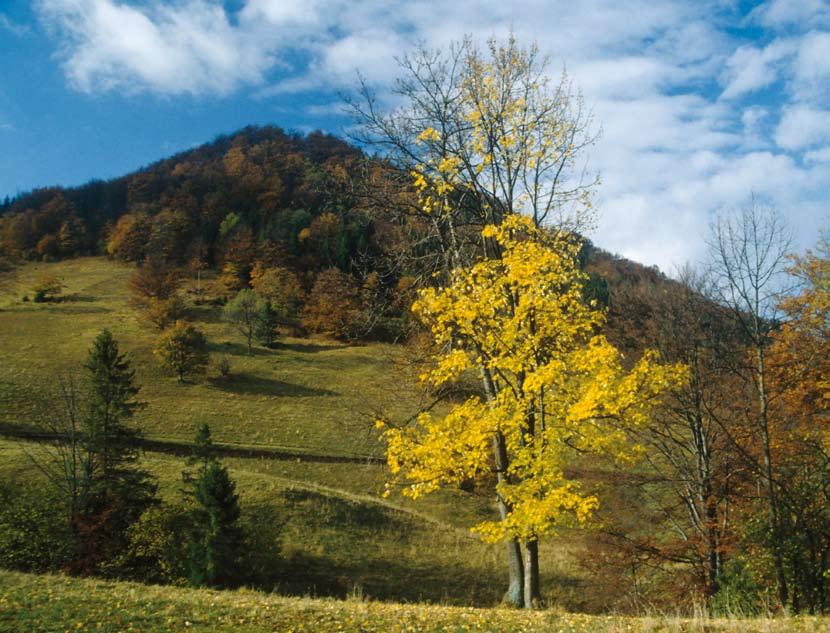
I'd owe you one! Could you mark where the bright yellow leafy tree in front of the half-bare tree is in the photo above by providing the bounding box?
[379,215,685,607]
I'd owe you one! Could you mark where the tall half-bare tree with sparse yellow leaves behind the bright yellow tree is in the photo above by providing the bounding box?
[351,36,597,605]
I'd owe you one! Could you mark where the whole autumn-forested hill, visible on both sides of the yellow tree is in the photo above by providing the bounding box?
[0,126,667,348]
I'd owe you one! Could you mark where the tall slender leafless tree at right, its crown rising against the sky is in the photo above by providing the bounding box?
[709,196,792,607]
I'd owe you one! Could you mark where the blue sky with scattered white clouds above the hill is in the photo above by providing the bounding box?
[0,0,830,273]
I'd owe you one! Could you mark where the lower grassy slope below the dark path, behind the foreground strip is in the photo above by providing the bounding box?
[0,440,585,608]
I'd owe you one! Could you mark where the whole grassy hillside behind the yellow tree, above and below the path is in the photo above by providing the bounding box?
[0,258,597,608]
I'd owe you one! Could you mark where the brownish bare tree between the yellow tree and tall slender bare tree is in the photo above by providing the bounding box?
[637,265,742,596]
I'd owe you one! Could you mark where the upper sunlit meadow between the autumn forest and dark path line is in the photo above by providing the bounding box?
[0,258,417,455]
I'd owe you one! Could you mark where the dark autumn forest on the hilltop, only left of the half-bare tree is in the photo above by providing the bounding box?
[0,127,367,264]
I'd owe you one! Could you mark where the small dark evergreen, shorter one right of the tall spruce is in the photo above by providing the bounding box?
[187,425,242,587]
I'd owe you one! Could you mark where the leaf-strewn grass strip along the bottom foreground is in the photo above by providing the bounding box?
[0,571,830,633]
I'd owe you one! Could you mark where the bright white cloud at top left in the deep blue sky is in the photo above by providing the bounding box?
[38,0,272,94]
